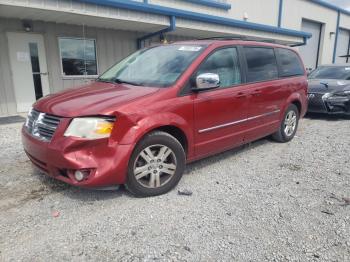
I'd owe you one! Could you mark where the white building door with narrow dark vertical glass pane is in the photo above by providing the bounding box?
[7,33,49,113]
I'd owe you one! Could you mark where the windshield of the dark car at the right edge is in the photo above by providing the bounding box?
[309,65,350,80]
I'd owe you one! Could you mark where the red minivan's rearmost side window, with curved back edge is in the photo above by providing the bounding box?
[277,48,304,76]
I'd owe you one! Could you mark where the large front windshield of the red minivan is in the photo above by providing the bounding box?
[98,45,204,87]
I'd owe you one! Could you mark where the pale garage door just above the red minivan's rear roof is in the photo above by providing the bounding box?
[299,20,322,70]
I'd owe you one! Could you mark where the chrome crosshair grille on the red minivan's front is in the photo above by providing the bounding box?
[25,109,61,142]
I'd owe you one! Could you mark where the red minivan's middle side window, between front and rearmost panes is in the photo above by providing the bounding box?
[244,47,278,82]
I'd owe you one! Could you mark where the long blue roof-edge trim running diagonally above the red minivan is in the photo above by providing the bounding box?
[76,0,312,38]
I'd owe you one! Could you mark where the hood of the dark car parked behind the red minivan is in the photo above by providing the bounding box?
[308,79,350,93]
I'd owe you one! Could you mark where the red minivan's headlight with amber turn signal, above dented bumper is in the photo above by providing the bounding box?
[64,117,115,139]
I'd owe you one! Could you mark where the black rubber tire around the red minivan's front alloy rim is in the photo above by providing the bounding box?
[125,131,186,197]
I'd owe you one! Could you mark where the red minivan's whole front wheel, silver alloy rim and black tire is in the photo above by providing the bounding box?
[126,131,186,197]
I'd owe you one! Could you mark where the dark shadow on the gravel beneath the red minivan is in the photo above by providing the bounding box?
[33,138,273,201]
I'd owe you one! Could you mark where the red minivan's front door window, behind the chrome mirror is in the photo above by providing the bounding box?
[197,47,242,87]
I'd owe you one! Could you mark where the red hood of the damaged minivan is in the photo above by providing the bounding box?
[34,82,159,117]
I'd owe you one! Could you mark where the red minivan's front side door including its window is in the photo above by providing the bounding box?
[193,47,248,157]
